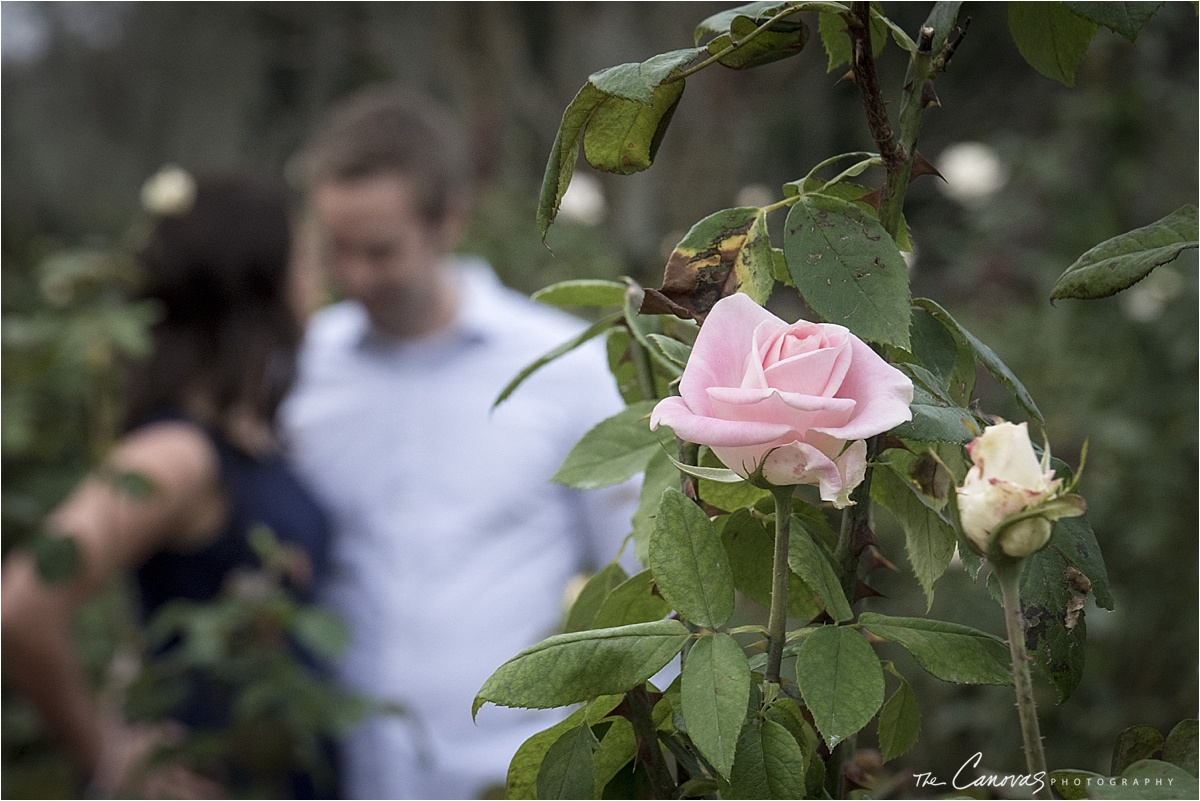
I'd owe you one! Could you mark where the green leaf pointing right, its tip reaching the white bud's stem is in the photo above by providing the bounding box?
[858,612,1013,685]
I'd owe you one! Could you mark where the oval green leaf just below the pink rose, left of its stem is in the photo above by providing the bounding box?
[648,488,734,628]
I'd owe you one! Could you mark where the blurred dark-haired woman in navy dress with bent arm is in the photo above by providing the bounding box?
[2,169,328,797]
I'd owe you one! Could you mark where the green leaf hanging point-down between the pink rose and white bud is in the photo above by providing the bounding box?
[871,452,958,607]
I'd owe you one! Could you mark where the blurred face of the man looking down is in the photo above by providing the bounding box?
[313,174,449,333]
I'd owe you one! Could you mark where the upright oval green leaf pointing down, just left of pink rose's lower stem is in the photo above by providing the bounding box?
[682,633,750,778]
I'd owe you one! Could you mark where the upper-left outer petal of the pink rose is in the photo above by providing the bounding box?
[679,293,787,414]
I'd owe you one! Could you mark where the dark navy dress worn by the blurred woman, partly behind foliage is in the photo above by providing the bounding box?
[136,414,335,799]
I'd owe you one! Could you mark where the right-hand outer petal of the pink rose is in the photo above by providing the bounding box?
[814,337,912,440]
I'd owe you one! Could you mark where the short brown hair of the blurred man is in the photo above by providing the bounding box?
[299,86,474,221]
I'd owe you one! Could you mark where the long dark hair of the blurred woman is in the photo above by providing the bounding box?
[126,174,300,441]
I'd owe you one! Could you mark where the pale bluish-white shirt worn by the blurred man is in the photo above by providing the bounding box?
[283,264,636,799]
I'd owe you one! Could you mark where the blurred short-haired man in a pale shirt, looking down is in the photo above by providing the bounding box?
[284,90,634,799]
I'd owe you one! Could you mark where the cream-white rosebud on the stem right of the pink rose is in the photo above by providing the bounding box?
[959,422,1085,559]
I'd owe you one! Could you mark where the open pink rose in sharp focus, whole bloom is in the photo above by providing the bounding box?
[650,293,912,508]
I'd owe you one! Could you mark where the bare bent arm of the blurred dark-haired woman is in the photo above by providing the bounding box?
[0,423,228,775]
